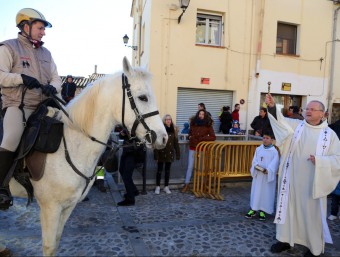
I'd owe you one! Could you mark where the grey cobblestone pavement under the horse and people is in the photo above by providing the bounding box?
[0,173,340,256]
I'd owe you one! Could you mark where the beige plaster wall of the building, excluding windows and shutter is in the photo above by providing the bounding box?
[132,0,340,127]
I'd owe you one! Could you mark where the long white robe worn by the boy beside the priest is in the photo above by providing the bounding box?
[250,145,279,214]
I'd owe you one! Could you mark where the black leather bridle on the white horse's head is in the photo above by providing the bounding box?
[122,73,159,144]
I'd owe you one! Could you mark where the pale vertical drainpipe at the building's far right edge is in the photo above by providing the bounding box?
[328,7,340,123]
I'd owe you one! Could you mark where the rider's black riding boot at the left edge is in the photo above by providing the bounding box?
[0,151,15,210]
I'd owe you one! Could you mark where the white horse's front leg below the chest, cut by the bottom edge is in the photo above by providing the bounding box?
[40,205,61,256]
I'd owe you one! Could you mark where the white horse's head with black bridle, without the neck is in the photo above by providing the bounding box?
[122,57,168,149]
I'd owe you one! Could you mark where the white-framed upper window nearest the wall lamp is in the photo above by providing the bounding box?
[196,13,222,46]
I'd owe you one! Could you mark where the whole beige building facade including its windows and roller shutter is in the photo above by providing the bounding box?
[131,0,340,131]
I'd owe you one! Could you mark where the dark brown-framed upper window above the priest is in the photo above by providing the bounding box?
[276,23,297,55]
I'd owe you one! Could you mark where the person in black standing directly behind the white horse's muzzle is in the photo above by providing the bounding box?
[117,129,146,206]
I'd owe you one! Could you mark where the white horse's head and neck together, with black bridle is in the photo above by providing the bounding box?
[63,58,168,149]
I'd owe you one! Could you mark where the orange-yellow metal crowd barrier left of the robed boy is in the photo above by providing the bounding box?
[193,141,262,200]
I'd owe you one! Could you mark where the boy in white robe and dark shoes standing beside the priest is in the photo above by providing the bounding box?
[245,130,279,220]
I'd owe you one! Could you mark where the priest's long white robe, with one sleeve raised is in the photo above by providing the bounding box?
[268,107,340,255]
